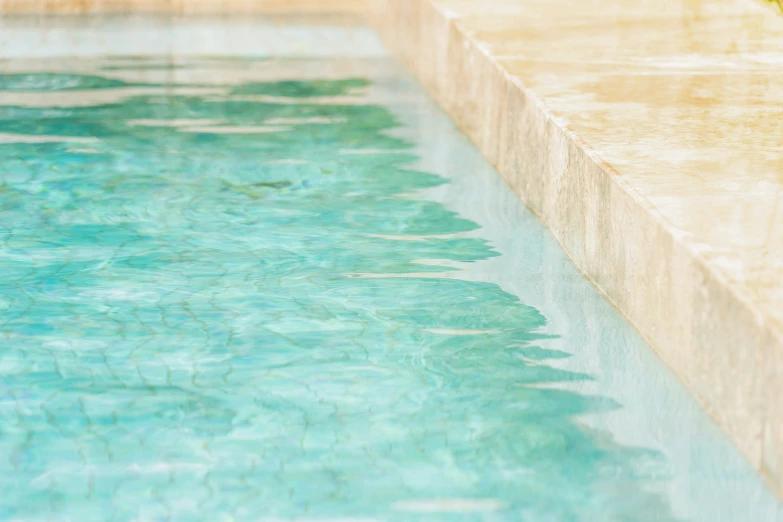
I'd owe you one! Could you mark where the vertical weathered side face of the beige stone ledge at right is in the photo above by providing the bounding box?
[368,0,783,497]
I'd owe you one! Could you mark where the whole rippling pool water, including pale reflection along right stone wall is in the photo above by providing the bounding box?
[0,19,780,520]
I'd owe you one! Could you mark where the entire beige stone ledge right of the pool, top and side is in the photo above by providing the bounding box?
[370,0,783,491]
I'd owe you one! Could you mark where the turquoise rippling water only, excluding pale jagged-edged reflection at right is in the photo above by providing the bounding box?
[0,53,780,522]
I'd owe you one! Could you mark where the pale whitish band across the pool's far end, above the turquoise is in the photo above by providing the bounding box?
[0,13,382,56]
